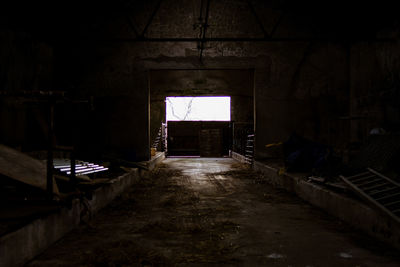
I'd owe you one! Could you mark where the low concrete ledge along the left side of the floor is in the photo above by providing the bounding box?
[0,169,139,267]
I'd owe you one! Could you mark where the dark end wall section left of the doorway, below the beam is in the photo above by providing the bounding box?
[50,43,150,161]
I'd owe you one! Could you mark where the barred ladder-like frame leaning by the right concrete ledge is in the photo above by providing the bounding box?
[340,168,400,223]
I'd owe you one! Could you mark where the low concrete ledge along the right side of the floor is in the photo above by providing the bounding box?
[253,161,400,249]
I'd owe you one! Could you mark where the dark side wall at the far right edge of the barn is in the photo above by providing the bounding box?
[350,42,400,142]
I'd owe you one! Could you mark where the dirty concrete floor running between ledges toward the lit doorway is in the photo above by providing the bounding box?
[29,158,400,266]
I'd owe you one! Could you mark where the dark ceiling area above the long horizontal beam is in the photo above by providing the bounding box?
[0,0,398,41]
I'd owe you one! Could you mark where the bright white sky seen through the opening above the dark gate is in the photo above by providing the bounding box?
[165,96,231,121]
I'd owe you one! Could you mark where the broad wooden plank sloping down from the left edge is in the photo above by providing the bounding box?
[0,144,59,195]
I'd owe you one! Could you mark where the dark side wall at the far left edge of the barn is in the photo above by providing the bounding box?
[0,27,54,149]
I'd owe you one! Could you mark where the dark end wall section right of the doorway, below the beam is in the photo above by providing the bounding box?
[255,43,349,158]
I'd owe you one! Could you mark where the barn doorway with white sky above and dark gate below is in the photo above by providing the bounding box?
[165,96,231,157]
